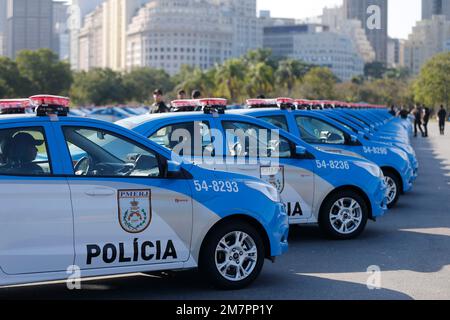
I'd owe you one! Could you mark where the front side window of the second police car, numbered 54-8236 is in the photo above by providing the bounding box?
[222,121,292,158]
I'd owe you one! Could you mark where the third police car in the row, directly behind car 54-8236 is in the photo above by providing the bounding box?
[235,98,414,208]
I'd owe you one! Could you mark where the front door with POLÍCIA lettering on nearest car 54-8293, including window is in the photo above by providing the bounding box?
[54,124,192,269]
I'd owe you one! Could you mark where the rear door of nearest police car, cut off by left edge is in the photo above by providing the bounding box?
[0,122,74,275]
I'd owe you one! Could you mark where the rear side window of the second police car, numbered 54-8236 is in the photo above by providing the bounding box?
[149,121,214,157]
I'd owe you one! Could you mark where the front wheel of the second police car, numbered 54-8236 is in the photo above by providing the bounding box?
[319,190,369,240]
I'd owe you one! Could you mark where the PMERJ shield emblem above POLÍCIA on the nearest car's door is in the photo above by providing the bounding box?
[117,190,152,233]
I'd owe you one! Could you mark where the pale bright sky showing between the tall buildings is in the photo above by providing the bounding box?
[258,0,422,39]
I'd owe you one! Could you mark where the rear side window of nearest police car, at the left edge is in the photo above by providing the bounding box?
[0,128,52,176]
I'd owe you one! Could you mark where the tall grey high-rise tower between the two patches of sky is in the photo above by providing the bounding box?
[344,0,388,62]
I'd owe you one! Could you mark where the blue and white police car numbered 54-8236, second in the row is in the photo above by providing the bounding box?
[118,99,387,239]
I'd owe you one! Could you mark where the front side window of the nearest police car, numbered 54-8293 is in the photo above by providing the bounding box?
[63,127,161,178]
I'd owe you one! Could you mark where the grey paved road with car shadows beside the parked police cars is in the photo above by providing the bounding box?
[0,123,450,300]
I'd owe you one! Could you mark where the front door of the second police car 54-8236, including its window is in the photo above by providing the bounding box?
[218,119,315,224]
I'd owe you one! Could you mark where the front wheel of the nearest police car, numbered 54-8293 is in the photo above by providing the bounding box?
[199,221,265,290]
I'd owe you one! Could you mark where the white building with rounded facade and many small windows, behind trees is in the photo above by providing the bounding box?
[127,0,234,74]
